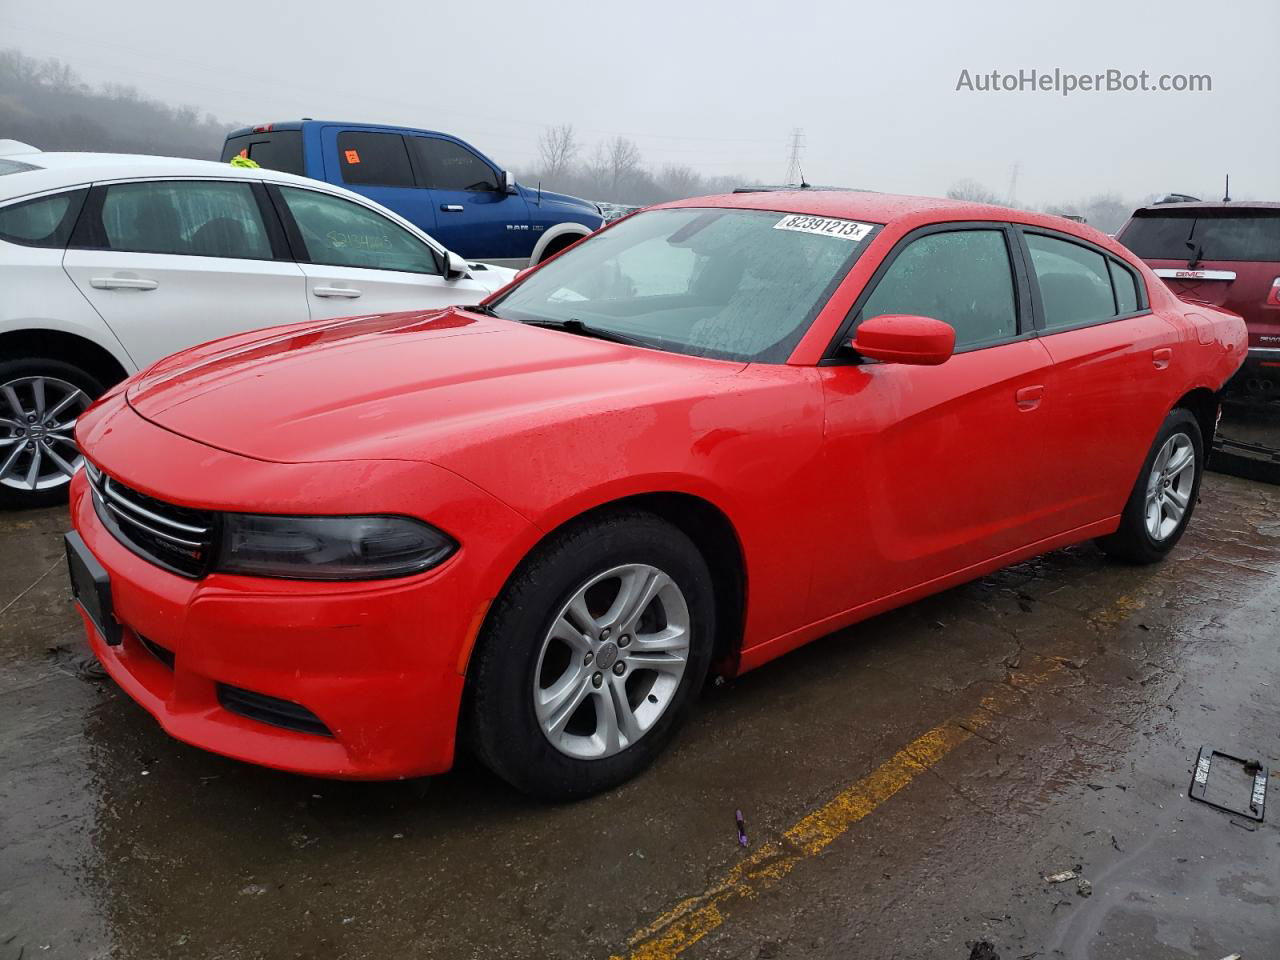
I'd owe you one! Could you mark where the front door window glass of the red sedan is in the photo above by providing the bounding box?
[861,229,1018,349]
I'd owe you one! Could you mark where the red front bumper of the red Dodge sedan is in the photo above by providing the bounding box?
[70,404,532,780]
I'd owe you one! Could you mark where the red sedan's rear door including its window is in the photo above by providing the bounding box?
[1020,228,1187,531]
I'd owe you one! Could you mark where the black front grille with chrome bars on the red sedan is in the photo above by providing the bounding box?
[84,461,216,579]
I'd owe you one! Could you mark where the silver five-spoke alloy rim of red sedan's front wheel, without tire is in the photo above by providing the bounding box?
[534,563,690,760]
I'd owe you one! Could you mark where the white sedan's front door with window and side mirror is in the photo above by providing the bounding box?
[270,184,488,320]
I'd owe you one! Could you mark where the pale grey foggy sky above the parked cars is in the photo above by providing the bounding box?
[0,0,1280,205]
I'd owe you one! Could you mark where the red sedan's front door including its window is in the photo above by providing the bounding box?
[812,223,1051,618]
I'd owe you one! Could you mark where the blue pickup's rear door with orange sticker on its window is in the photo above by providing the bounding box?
[320,127,448,246]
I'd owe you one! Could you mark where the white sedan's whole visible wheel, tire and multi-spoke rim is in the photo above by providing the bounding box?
[0,357,104,508]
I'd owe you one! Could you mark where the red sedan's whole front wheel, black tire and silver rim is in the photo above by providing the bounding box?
[468,512,714,800]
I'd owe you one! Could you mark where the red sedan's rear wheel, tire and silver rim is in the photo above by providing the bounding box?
[1098,407,1204,563]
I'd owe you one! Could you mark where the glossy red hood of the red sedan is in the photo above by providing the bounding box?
[127,308,744,462]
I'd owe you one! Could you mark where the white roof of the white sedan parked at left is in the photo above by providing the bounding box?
[0,152,325,200]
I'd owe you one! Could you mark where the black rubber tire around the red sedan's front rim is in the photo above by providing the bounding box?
[465,511,716,800]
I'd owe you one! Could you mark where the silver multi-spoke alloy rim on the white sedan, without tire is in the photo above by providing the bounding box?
[0,376,91,493]
